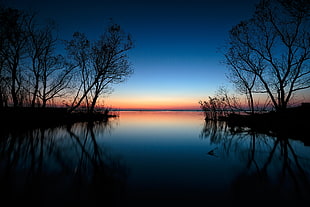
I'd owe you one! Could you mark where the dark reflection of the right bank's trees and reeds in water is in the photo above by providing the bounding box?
[202,120,310,203]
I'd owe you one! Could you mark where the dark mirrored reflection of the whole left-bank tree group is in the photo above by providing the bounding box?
[0,119,127,206]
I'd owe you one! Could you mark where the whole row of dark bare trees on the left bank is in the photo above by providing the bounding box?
[0,7,133,112]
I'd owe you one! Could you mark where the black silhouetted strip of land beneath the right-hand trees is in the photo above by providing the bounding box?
[218,104,310,146]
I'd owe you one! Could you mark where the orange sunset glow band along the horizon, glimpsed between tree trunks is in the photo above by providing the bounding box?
[49,89,310,110]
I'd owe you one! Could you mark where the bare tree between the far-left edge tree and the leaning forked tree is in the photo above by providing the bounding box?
[28,19,74,108]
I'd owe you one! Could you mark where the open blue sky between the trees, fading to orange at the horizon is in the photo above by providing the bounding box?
[4,0,258,109]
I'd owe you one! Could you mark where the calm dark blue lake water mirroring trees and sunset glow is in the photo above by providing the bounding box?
[0,112,310,206]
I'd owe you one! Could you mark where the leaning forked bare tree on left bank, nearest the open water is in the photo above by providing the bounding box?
[67,24,133,112]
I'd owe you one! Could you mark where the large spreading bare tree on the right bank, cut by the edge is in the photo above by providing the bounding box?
[225,0,310,111]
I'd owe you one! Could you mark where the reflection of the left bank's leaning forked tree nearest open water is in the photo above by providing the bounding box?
[67,120,127,203]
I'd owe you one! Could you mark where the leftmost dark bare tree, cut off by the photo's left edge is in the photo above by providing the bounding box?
[0,8,32,107]
